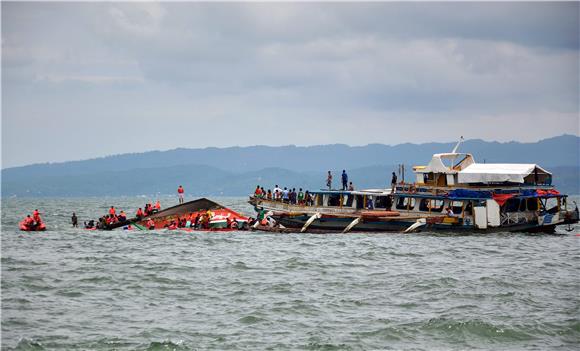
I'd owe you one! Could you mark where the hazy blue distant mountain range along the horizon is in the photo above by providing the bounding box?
[2,135,580,197]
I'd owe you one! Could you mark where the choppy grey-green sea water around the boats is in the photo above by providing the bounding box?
[1,198,580,350]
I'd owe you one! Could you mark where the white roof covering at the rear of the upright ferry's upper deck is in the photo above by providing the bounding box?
[457,163,551,183]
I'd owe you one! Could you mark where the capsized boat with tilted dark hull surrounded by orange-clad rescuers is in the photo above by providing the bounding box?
[136,198,248,231]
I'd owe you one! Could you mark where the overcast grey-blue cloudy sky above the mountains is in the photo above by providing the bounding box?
[1,1,580,168]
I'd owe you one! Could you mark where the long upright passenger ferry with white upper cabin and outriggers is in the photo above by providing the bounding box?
[249,147,578,233]
